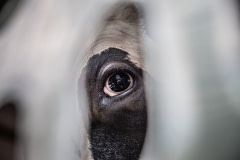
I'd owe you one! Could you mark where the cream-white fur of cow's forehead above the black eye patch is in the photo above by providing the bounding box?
[81,1,145,69]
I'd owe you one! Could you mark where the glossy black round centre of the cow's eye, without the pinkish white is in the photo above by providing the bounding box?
[108,72,131,92]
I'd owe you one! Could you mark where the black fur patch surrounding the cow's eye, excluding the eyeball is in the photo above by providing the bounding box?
[84,48,147,160]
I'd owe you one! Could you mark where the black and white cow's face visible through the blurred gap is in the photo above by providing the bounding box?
[81,3,147,160]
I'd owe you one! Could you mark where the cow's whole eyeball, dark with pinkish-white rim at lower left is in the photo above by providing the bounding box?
[103,71,133,97]
